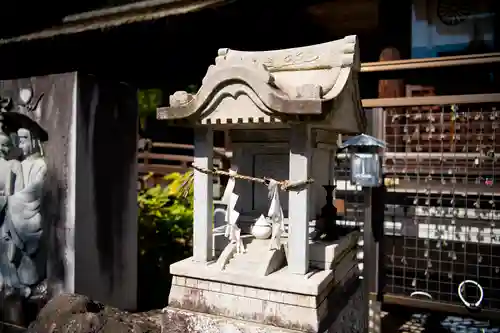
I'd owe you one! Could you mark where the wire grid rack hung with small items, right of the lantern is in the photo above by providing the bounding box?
[383,104,500,309]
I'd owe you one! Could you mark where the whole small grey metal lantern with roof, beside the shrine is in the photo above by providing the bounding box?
[340,134,386,187]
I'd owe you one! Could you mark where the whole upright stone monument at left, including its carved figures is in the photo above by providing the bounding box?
[0,72,138,310]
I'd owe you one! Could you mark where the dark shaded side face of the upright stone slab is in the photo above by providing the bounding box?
[73,73,138,310]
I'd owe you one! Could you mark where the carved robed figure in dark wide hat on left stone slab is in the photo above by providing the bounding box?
[0,91,48,298]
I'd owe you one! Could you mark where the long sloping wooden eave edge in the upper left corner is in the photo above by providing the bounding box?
[0,0,233,46]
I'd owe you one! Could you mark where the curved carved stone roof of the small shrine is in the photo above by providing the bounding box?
[157,36,365,132]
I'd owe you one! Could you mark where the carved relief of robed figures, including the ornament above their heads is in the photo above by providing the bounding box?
[0,89,48,299]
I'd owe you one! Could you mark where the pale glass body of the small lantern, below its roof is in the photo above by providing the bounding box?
[351,153,382,187]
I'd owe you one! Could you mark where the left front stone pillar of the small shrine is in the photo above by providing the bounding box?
[193,126,213,262]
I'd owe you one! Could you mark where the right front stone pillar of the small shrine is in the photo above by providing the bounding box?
[288,124,311,275]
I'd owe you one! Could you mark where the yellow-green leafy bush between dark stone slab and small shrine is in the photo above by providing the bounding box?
[137,172,193,309]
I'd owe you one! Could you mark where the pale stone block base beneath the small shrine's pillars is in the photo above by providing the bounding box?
[170,233,363,332]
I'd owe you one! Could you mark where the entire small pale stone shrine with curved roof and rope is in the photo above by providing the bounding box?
[158,36,366,332]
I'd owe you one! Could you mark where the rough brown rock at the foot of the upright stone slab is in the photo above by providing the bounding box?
[26,294,161,333]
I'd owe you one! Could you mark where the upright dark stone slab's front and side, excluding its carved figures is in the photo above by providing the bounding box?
[0,73,138,324]
